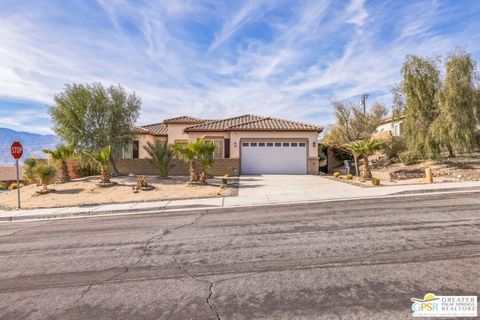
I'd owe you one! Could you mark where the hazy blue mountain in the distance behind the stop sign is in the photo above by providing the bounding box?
[0,128,60,165]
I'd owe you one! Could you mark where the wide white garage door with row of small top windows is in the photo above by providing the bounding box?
[240,140,307,174]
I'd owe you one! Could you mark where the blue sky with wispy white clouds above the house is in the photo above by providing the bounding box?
[0,0,480,133]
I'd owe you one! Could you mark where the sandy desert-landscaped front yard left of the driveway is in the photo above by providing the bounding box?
[0,176,234,209]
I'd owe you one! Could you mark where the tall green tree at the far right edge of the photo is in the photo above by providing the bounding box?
[433,51,477,157]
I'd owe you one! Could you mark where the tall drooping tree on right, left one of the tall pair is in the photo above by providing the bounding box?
[402,56,441,159]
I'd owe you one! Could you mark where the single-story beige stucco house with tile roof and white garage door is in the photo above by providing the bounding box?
[116,114,322,174]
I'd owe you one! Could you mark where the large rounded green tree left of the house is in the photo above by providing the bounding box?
[49,83,141,173]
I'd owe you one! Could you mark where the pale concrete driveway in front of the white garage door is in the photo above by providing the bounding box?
[239,175,369,201]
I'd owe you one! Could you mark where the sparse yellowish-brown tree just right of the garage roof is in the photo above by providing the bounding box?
[323,98,386,146]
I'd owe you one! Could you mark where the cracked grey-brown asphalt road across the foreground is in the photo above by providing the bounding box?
[0,193,480,320]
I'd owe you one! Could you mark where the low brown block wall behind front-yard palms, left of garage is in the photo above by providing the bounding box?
[115,159,240,176]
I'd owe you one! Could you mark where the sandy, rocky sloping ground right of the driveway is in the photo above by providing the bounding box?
[332,153,480,186]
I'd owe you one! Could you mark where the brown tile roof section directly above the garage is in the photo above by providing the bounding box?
[185,114,323,132]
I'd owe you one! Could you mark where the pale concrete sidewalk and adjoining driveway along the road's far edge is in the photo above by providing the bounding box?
[0,176,480,221]
